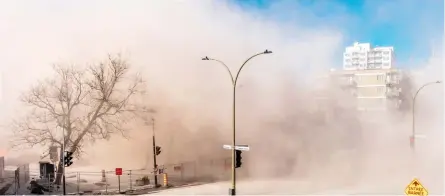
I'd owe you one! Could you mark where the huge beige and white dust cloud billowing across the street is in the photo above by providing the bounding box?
[3,0,443,193]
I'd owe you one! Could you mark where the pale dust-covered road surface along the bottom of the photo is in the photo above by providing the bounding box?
[147,179,442,195]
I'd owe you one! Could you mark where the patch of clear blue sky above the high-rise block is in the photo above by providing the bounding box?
[232,0,444,66]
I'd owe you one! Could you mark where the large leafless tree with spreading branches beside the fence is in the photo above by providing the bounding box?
[12,55,143,184]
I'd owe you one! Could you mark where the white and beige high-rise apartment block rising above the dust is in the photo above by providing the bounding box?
[314,42,410,111]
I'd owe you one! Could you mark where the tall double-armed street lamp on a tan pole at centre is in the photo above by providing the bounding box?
[202,50,272,195]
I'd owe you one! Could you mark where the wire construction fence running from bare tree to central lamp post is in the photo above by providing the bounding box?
[65,158,231,194]
